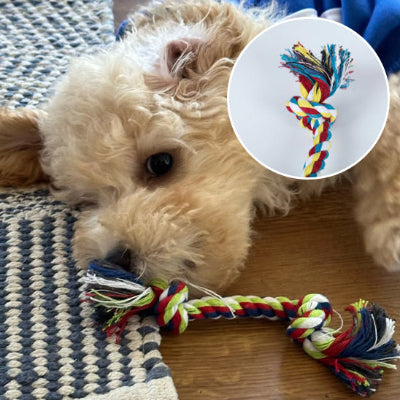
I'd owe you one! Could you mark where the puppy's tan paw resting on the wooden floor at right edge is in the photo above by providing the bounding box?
[365,217,400,272]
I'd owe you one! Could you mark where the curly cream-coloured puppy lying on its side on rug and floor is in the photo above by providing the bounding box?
[0,0,400,292]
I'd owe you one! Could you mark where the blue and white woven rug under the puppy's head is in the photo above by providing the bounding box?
[0,0,177,400]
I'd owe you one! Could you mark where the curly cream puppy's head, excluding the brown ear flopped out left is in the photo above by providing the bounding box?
[40,0,276,290]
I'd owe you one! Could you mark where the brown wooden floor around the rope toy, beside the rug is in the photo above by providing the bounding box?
[114,0,400,400]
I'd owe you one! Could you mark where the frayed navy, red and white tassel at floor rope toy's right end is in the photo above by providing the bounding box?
[303,300,400,397]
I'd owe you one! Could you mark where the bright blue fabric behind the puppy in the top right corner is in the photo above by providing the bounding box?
[226,0,400,73]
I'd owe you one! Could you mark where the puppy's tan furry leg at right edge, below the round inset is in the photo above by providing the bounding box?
[353,76,400,270]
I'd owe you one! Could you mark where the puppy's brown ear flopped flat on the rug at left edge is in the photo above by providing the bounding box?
[0,109,48,186]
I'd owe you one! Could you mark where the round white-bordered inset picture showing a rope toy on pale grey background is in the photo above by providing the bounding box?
[228,18,389,179]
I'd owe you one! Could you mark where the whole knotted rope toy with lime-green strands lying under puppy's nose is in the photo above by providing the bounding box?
[86,261,400,396]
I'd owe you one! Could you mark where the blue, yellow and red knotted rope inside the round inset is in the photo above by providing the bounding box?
[281,43,353,177]
